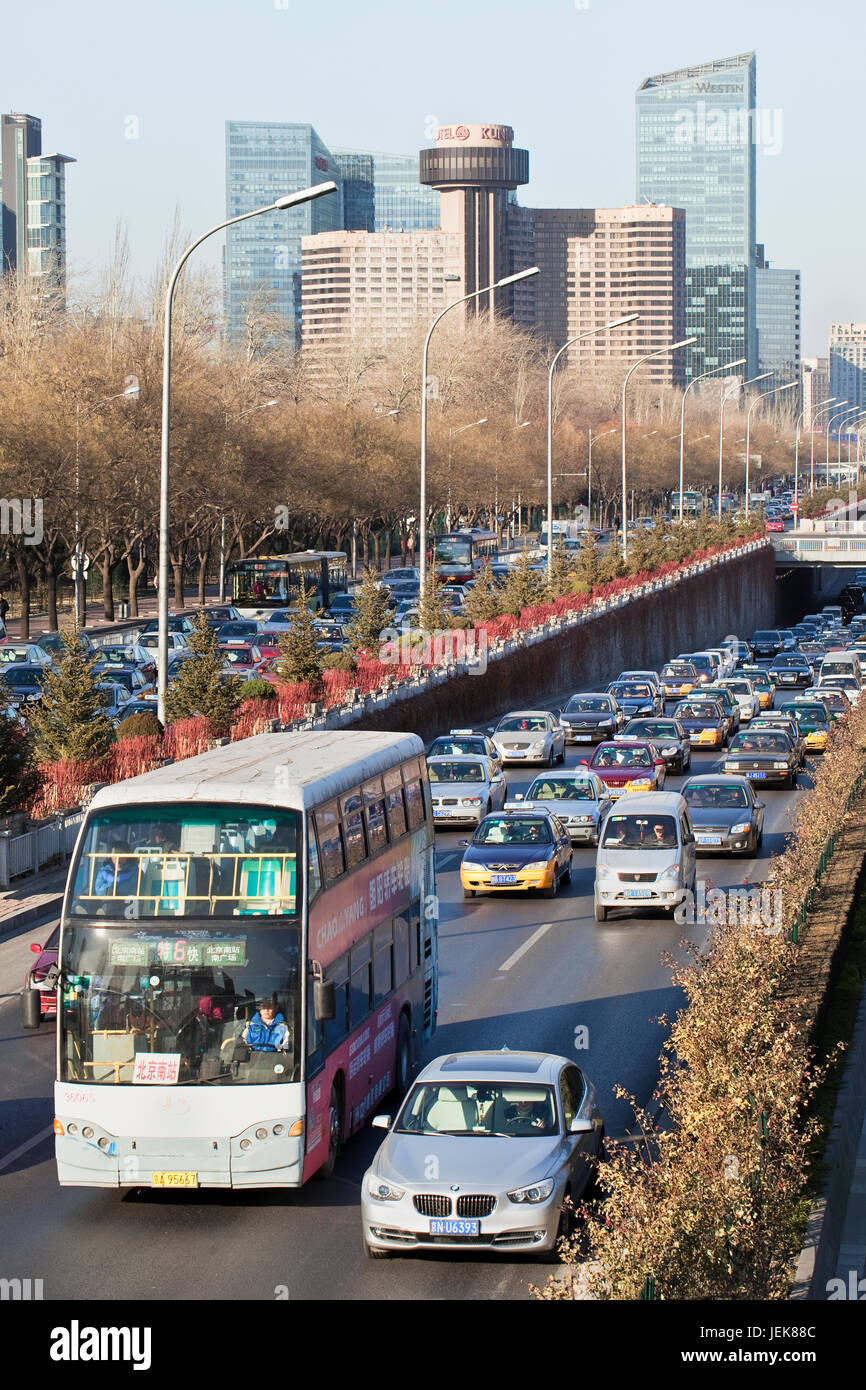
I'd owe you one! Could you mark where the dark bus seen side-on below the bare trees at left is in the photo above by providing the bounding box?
[231,550,349,619]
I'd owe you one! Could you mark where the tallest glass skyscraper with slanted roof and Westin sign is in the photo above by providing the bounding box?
[635,53,758,381]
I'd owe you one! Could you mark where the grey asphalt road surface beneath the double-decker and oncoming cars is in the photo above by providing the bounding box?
[0,667,810,1300]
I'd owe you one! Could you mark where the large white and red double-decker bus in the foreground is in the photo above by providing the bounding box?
[54,731,438,1187]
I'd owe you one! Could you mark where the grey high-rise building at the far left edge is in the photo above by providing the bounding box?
[0,114,75,303]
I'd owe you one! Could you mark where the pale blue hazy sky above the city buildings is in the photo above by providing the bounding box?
[8,0,866,356]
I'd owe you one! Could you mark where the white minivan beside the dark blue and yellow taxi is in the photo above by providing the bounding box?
[595,791,698,922]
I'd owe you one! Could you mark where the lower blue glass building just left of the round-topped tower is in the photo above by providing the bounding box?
[334,147,439,232]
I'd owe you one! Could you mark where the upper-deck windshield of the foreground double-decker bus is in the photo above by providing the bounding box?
[70,802,299,920]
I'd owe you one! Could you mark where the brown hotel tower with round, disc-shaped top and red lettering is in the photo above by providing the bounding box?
[420,125,530,316]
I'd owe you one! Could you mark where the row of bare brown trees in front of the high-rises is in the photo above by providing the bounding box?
[0,246,791,631]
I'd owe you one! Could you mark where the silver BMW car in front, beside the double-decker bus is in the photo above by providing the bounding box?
[361,1048,605,1258]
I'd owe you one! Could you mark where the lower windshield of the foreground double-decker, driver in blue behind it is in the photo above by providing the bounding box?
[60,926,300,1086]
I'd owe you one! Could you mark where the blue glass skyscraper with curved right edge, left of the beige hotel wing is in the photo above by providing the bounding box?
[225,121,343,345]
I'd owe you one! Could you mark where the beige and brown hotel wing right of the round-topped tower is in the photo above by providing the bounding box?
[509,204,685,386]
